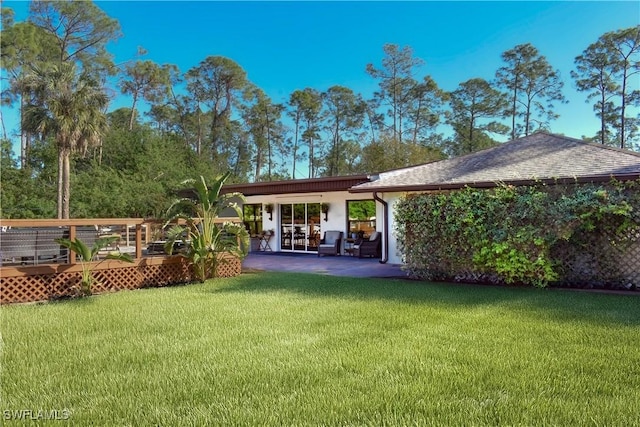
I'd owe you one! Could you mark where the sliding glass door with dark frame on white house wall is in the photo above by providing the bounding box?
[280,203,320,252]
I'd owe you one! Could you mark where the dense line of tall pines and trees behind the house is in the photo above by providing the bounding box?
[0,1,640,218]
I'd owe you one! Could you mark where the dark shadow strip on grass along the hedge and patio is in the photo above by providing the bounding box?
[210,272,640,326]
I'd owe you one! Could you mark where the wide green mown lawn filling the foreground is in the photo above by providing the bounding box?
[1,273,640,426]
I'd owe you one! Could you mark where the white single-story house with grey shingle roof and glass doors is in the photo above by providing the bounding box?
[223,132,640,264]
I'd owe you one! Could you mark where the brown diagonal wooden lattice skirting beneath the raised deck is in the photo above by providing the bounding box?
[0,256,242,304]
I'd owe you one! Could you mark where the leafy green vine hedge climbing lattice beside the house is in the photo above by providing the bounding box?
[395,181,640,287]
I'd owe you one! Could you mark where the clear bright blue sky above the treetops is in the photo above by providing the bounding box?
[3,1,640,150]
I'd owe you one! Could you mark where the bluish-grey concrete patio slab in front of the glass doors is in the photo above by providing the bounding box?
[242,252,407,278]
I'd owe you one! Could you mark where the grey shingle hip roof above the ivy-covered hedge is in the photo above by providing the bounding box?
[351,132,640,192]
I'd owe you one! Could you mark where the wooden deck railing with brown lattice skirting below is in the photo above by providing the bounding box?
[0,218,241,304]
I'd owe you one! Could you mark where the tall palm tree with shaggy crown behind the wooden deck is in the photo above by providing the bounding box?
[22,63,109,219]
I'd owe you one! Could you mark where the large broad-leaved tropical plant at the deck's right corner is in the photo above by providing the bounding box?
[165,172,249,282]
